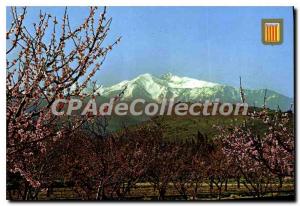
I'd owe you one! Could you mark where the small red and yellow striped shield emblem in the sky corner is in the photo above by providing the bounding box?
[262,19,283,45]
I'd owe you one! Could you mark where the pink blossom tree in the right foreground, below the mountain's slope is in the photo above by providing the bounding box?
[221,110,294,197]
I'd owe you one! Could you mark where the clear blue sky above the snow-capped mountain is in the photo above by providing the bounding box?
[7,7,294,97]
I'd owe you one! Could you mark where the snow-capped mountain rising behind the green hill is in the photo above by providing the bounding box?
[98,73,293,110]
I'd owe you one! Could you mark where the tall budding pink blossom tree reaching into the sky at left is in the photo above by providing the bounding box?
[6,7,120,196]
